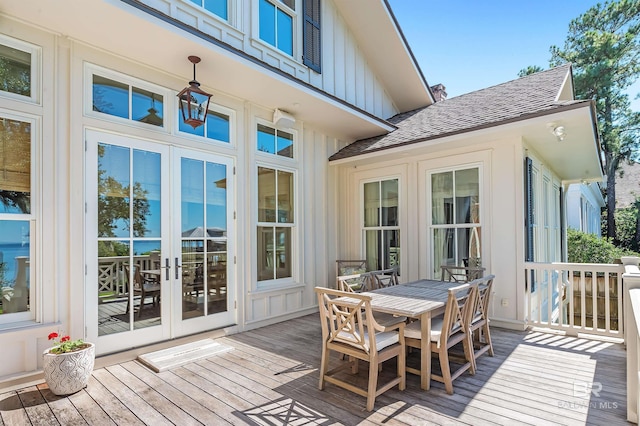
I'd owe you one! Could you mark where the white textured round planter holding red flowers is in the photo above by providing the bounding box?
[42,342,96,395]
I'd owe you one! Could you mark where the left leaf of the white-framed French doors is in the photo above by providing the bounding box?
[87,131,171,353]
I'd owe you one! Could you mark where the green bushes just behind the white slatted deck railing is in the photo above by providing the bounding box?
[567,229,637,263]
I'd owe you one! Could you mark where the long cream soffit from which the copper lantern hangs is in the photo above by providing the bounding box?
[0,0,393,141]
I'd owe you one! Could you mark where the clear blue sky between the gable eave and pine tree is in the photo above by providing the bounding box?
[389,0,640,111]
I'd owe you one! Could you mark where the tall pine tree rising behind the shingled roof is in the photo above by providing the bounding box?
[551,0,640,238]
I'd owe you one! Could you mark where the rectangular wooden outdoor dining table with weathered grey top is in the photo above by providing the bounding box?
[362,279,460,390]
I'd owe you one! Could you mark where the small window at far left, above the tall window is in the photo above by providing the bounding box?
[0,35,40,101]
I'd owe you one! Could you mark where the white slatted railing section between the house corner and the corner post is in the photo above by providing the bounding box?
[525,262,624,338]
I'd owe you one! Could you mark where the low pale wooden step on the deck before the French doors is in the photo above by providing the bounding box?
[138,339,233,373]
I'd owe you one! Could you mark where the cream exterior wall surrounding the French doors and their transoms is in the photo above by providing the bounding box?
[0,17,344,386]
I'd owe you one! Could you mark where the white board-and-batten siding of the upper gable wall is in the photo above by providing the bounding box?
[144,0,399,118]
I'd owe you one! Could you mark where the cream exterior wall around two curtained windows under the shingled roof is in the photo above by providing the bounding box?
[331,132,559,328]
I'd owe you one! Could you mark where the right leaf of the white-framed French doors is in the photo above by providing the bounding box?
[176,150,233,334]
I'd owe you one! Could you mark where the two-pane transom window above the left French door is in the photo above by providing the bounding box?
[91,73,164,127]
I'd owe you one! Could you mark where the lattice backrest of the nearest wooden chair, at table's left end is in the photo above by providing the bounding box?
[315,287,380,354]
